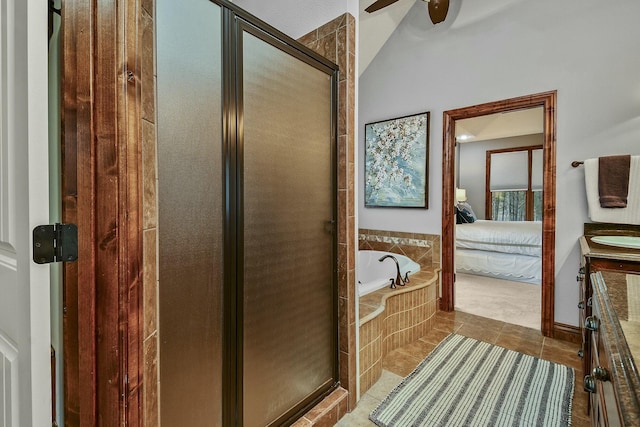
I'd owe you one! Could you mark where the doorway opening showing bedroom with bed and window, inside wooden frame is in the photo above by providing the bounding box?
[455,107,544,329]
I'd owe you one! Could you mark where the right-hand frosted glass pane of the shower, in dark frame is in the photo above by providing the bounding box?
[239,26,337,427]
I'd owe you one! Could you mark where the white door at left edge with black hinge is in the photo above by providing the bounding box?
[0,0,51,427]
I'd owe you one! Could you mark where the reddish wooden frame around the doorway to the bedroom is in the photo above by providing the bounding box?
[442,91,557,336]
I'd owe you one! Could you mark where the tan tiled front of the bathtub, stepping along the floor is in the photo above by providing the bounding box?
[359,269,438,394]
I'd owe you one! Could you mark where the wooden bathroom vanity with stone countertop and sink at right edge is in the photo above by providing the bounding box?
[578,224,640,426]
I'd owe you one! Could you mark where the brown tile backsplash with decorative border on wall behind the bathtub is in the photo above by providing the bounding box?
[358,228,440,268]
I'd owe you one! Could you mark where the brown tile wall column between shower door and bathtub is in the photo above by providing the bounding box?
[298,13,358,409]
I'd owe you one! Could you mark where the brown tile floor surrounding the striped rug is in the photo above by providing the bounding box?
[336,311,590,427]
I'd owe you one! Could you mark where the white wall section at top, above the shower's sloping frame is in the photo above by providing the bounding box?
[232,0,358,39]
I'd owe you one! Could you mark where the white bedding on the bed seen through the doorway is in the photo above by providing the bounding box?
[455,220,542,257]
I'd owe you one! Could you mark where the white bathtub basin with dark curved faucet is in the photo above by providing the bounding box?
[358,251,420,296]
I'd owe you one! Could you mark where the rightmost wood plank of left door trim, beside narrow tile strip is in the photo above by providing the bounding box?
[117,1,144,426]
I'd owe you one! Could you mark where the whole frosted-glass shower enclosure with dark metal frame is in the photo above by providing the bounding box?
[156,0,338,426]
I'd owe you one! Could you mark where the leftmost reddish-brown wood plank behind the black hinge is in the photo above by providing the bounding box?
[62,1,96,426]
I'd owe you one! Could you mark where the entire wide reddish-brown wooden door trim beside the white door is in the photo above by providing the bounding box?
[62,0,142,426]
